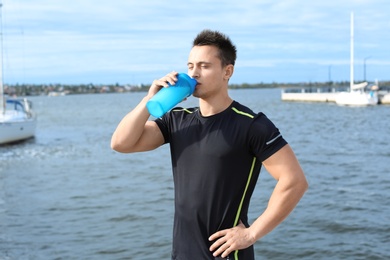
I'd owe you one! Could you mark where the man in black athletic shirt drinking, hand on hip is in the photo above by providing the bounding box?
[111,30,308,260]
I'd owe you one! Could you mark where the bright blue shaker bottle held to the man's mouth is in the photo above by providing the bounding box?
[146,73,197,118]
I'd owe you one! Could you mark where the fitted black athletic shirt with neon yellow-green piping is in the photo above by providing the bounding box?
[155,101,287,260]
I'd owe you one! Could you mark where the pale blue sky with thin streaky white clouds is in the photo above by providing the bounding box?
[2,0,390,84]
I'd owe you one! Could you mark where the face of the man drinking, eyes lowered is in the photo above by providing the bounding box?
[188,46,232,99]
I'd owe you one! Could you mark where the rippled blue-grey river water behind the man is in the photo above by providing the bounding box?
[0,89,390,260]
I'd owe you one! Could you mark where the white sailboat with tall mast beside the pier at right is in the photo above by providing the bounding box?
[335,12,378,106]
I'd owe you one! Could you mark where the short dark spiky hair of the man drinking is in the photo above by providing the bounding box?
[193,29,237,66]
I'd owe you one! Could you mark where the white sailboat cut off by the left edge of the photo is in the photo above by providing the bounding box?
[0,3,37,144]
